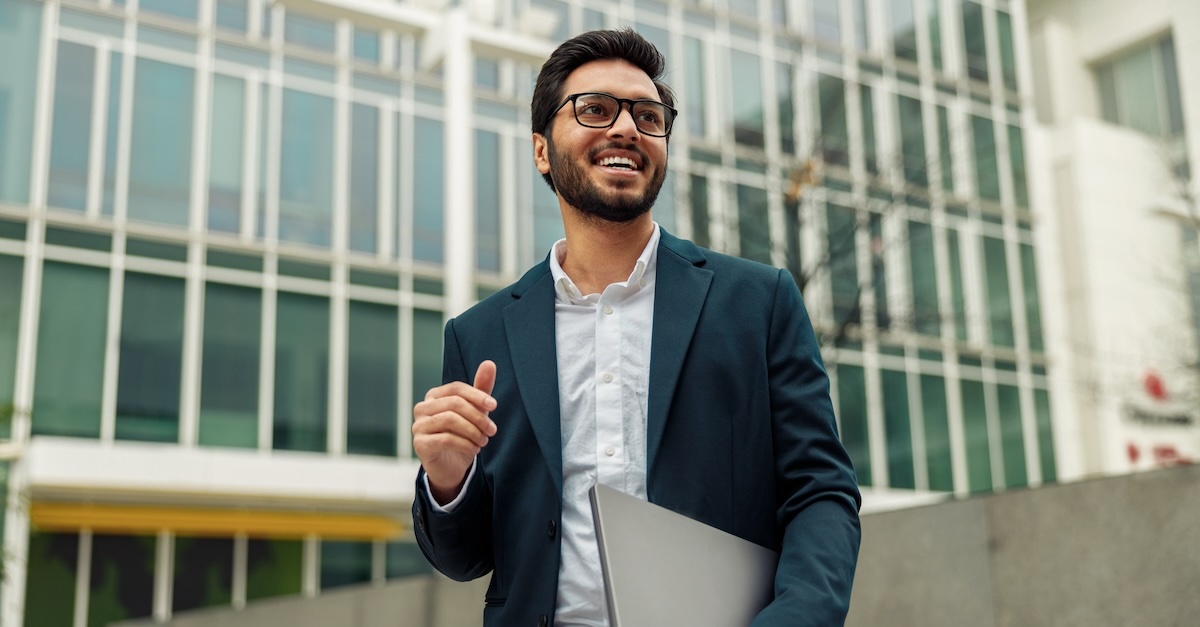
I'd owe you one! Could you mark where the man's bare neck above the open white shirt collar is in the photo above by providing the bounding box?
[562,209,654,294]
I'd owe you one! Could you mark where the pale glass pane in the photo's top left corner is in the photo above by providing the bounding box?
[0,0,42,204]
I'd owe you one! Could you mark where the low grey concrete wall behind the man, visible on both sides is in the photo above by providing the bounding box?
[119,466,1200,627]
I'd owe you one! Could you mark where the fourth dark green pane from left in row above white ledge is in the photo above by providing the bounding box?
[274,292,329,450]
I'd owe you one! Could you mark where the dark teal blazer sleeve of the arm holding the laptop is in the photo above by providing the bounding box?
[752,270,862,627]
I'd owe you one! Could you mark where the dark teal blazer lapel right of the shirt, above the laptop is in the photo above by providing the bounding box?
[646,231,713,478]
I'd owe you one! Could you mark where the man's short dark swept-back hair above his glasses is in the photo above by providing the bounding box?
[529,28,674,189]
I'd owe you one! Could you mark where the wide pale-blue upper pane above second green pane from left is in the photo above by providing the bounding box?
[130,58,196,226]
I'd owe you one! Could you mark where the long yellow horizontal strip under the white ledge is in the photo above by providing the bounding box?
[30,502,403,541]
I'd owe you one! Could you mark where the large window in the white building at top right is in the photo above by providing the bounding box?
[1096,35,1183,137]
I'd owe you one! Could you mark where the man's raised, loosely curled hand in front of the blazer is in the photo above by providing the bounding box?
[413,360,496,504]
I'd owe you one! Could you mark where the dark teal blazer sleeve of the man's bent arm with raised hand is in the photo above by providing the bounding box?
[413,320,494,581]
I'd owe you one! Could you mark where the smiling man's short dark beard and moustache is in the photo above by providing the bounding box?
[546,137,667,223]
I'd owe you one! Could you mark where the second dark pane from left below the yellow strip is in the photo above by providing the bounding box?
[88,535,155,627]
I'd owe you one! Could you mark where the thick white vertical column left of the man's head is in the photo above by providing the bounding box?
[444,7,475,317]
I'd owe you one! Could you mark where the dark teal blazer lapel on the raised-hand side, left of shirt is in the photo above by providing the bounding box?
[504,262,563,495]
